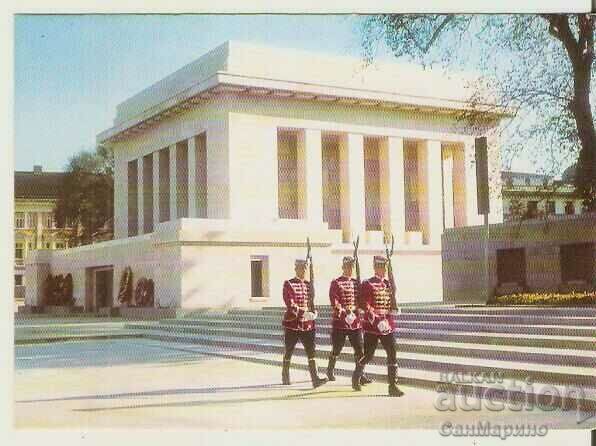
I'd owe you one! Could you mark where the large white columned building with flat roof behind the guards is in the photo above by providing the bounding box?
[27,42,505,310]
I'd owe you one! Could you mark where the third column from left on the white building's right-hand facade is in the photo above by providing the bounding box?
[379,137,406,245]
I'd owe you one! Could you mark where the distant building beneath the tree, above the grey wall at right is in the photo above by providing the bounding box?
[501,166,583,221]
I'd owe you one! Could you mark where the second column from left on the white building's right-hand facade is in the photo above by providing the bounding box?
[340,133,366,242]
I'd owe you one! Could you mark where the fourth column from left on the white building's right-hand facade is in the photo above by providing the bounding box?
[425,141,443,247]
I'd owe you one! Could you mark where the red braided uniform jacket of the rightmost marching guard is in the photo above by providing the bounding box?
[360,276,395,335]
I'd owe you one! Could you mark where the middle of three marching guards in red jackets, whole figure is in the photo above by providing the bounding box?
[327,256,371,384]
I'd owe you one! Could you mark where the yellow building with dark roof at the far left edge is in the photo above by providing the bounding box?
[14,166,68,300]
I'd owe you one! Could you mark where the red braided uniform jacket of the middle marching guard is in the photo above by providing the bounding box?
[329,276,362,330]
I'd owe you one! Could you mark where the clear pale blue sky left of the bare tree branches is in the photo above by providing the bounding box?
[15,15,544,171]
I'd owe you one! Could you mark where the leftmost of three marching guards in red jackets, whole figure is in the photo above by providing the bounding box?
[282,259,327,388]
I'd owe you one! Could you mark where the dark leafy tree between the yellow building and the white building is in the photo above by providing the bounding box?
[54,146,114,246]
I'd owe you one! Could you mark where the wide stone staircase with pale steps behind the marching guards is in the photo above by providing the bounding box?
[125,305,596,412]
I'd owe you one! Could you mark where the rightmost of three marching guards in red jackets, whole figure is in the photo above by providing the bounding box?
[352,256,403,396]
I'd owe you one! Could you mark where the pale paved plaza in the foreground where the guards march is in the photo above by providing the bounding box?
[14,338,596,430]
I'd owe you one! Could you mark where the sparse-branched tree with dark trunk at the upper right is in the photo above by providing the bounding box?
[362,14,596,210]
